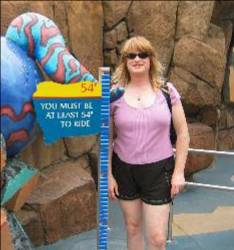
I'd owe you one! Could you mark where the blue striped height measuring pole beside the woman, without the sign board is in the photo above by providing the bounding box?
[98,67,110,250]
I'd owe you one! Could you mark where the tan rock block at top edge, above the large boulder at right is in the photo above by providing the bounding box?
[176,1,214,40]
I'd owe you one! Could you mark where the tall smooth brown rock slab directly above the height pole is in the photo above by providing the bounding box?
[66,1,103,79]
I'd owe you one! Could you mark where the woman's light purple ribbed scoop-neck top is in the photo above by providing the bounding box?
[111,83,180,164]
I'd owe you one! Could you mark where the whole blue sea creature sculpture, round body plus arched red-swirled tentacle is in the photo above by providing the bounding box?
[1,13,96,157]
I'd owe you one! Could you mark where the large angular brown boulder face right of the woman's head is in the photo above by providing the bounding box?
[174,37,226,88]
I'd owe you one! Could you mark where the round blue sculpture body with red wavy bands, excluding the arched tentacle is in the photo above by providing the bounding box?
[1,37,43,156]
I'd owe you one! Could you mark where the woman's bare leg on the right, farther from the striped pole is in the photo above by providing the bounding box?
[143,203,170,250]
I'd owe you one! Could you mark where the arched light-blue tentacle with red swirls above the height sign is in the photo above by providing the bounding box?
[6,12,96,83]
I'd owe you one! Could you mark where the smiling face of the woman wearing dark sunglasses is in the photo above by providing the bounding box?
[126,51,150,75]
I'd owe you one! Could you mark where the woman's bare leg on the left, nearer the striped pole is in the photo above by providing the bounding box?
[120,199,144,250]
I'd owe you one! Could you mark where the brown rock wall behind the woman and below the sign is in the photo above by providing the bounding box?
[1,1,234,245]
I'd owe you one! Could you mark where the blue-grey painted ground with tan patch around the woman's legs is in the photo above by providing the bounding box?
[37,153,234,250]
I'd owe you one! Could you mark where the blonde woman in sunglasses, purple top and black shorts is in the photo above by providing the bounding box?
[109,36,189,250]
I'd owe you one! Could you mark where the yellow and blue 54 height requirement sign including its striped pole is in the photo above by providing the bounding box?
[33,67,110,250]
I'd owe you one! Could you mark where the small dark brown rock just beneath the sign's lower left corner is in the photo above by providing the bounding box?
[20,134,67,168]
